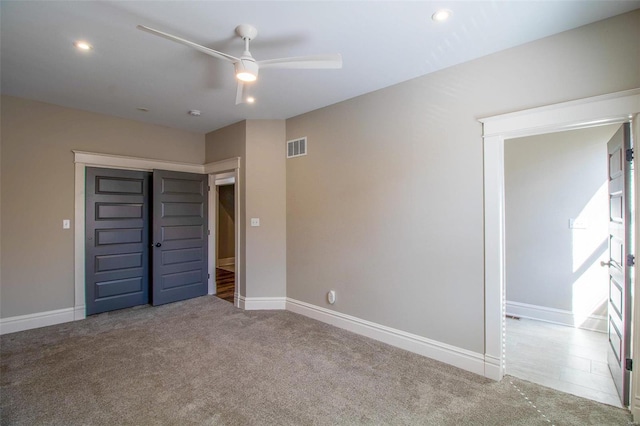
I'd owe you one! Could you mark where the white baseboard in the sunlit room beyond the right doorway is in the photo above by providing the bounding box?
[506,301,607,333]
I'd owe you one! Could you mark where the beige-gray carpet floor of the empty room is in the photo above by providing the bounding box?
[0,296,631,425]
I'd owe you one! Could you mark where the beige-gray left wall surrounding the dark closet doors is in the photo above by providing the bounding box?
[0,96,205,318]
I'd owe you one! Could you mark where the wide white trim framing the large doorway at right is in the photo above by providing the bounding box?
[478,88,640,408]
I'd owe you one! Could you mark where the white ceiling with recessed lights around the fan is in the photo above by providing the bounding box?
[0,0,640,133]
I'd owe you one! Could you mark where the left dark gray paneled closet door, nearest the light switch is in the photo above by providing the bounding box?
[85,167,150,315]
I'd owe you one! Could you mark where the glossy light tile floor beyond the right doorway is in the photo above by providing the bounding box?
[505,318,622,407]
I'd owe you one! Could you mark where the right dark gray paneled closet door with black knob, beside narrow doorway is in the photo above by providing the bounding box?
[151,170,208,305]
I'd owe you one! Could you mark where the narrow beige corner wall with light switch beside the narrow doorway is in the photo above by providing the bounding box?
[206,120,287,297]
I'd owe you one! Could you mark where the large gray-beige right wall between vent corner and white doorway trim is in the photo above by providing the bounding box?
[287,11,640,353]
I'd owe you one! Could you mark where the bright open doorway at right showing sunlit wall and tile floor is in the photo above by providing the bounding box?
[504,124,622,407]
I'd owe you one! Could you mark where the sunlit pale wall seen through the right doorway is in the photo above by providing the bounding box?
[504,125,620,314]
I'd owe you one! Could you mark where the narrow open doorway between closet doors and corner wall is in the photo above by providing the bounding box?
[214,173,237,303]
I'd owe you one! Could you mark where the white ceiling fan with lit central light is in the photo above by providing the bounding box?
[137,24,342,105]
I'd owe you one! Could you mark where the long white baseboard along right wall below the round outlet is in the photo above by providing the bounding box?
[286,298,486,375]
